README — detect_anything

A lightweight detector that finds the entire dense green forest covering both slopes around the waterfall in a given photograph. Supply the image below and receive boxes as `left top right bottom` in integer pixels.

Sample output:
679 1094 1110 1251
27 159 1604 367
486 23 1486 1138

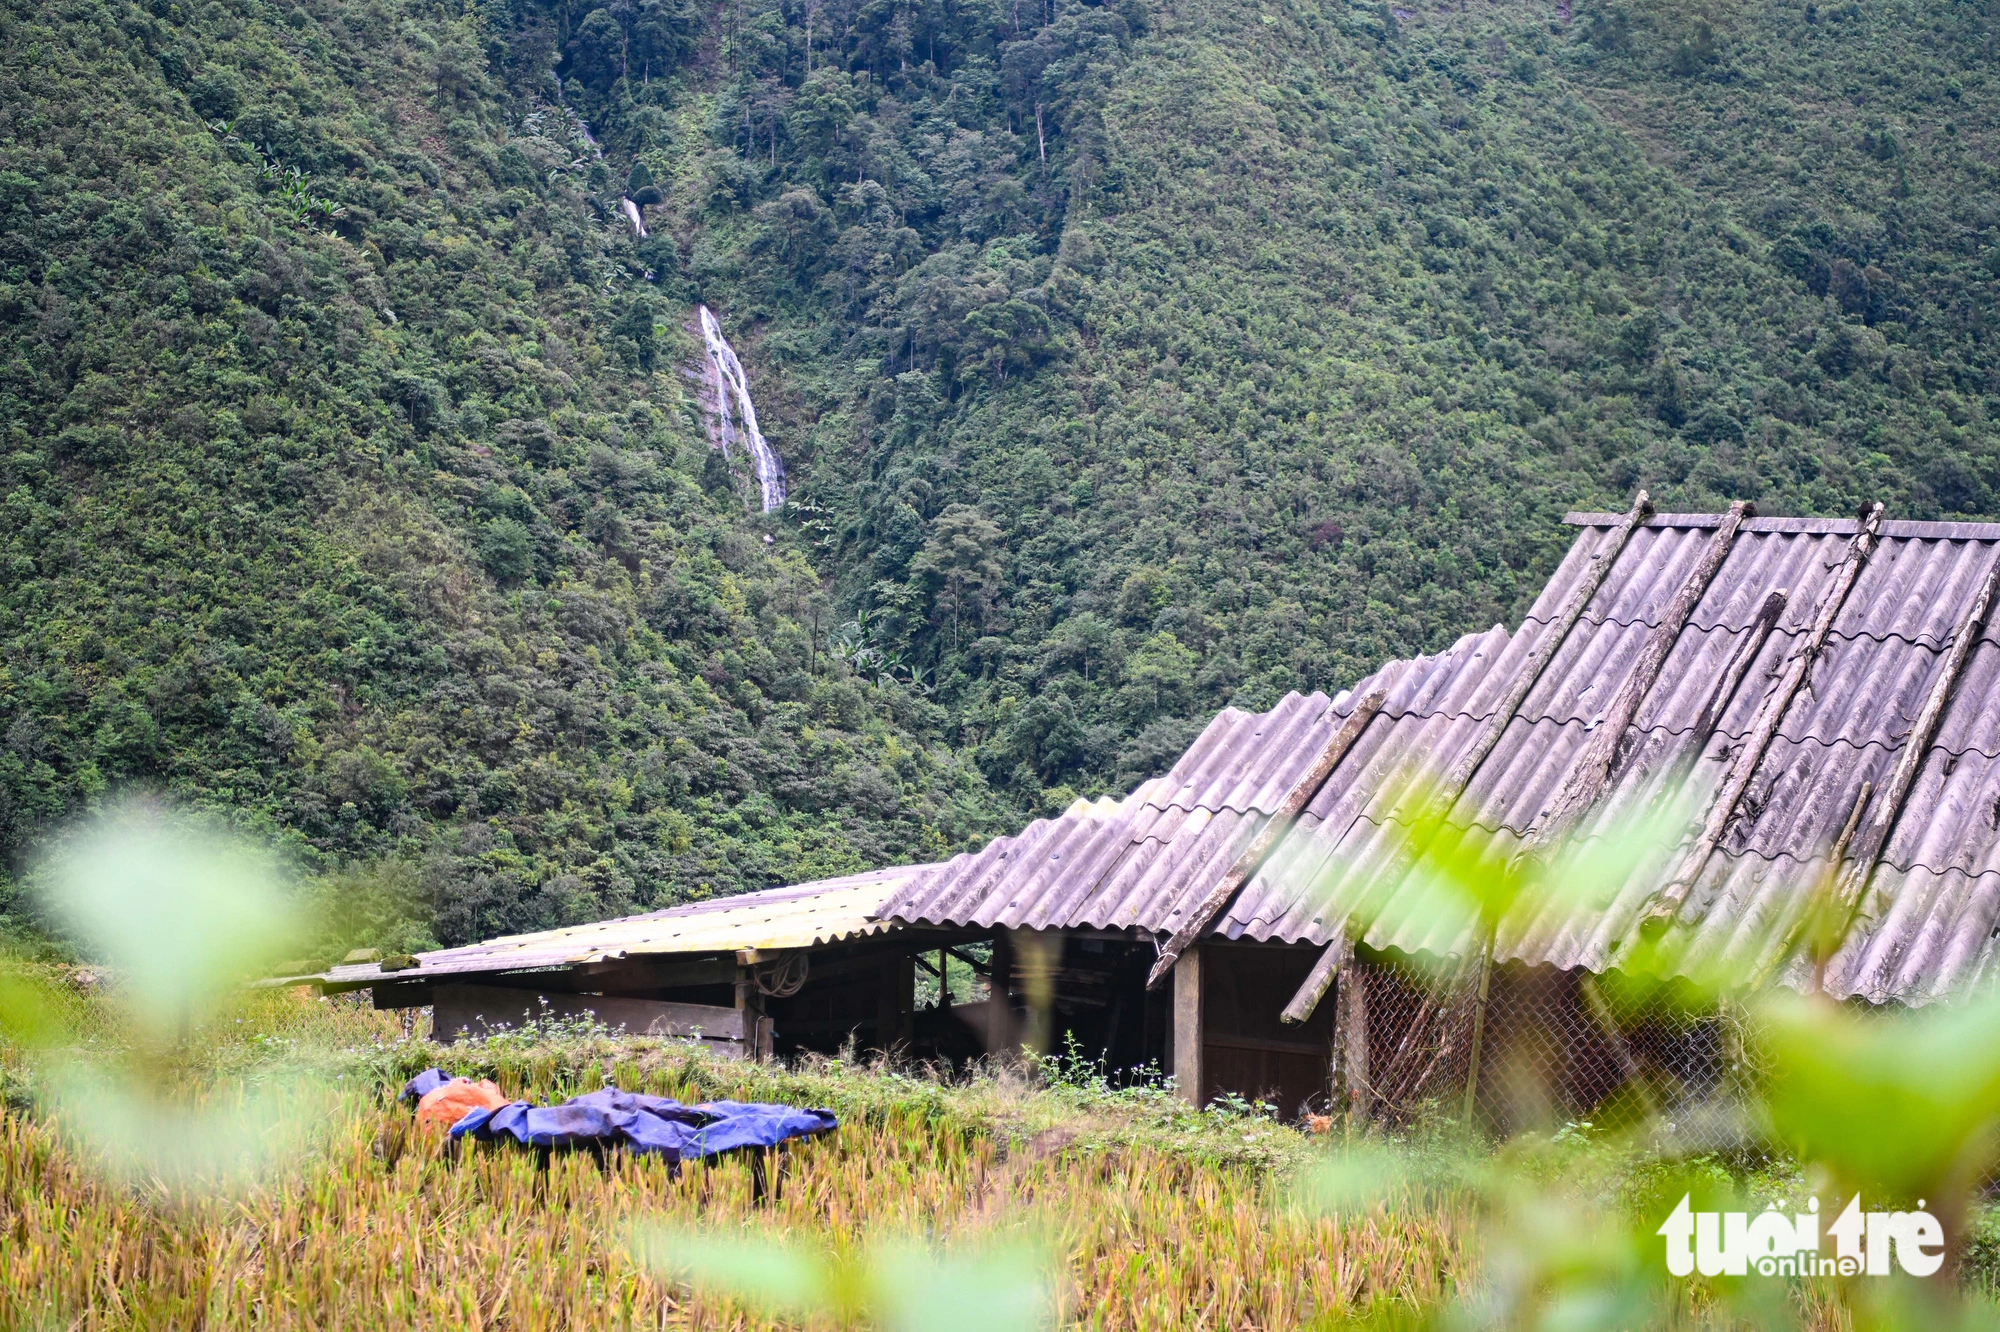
0 0 2000 948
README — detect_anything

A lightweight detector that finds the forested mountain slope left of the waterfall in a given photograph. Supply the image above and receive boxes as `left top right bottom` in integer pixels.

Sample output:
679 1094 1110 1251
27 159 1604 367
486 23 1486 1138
0 2 1002 940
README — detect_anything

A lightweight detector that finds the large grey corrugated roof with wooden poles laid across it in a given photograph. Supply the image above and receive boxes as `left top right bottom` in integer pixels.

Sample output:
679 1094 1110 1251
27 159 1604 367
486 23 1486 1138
882 514 2000 1002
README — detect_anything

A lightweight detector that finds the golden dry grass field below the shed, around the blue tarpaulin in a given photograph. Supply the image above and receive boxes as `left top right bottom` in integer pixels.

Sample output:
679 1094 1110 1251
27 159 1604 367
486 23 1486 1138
0 980 1466 1332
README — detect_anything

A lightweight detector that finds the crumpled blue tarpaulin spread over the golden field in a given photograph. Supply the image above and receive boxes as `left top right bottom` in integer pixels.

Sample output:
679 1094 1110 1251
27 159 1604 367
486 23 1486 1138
404 1068 840 1160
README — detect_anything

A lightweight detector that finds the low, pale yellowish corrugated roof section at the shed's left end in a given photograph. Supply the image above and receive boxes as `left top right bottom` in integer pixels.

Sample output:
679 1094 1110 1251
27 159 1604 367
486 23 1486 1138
318 866 932 988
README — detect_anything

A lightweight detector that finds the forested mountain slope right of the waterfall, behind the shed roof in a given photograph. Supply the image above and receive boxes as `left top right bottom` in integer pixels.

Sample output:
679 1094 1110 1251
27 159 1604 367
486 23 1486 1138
676 0 2000 790
